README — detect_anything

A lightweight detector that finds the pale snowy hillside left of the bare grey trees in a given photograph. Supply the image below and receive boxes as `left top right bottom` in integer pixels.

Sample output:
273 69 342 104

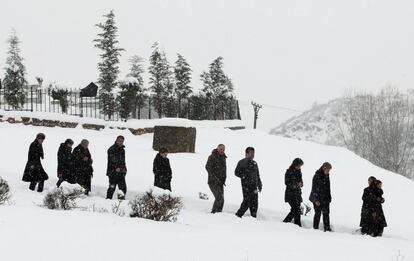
270 99 342 145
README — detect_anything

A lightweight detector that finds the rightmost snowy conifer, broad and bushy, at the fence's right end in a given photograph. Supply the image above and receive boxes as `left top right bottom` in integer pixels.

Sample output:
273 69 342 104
201 57 234 120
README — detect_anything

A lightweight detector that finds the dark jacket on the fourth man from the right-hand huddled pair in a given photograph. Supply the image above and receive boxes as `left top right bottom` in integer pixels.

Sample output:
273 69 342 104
234 158 262 191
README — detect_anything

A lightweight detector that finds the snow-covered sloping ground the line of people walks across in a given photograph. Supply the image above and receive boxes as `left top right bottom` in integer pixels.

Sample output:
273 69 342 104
0 123 414 261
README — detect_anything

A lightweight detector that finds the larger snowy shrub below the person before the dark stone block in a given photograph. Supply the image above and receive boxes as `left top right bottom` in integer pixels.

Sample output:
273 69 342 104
129 190 183 222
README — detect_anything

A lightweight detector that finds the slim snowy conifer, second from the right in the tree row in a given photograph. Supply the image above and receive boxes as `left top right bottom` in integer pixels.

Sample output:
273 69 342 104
174 54 193 118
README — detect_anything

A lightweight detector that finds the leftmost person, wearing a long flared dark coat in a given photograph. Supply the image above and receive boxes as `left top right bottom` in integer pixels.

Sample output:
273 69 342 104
22 133 49 192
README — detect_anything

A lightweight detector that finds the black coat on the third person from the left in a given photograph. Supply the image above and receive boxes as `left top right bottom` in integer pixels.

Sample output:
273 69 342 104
73 144 93 185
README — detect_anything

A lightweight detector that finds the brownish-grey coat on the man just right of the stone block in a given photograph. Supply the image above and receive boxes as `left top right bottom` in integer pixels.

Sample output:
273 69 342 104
206 149 227 185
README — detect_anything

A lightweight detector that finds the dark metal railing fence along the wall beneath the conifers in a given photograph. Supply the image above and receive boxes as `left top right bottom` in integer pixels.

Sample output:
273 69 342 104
0 87 240 121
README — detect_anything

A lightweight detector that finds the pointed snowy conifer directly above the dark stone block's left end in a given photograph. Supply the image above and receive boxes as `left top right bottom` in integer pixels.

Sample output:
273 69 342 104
149 42 173 118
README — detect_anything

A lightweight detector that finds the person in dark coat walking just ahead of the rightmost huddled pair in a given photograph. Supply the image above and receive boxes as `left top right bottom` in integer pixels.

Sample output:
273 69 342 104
309 162 332 232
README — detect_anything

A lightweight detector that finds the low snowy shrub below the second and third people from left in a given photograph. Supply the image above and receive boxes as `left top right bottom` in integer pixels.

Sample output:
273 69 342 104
43 187 84 210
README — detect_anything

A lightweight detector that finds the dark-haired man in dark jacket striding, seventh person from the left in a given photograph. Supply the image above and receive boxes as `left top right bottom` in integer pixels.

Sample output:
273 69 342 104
235 147 262 218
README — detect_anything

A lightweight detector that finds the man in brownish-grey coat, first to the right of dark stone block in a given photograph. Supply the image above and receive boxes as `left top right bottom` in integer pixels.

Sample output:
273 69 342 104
206 144 227 213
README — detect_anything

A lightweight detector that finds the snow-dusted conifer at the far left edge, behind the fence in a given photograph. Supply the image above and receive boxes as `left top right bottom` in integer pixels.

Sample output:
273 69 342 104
3 30 27 109
